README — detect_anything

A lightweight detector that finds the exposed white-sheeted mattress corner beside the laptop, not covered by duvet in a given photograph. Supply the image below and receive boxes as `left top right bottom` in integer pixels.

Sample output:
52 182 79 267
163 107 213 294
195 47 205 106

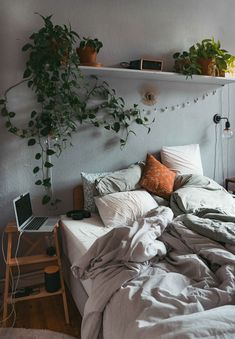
61 213 110 295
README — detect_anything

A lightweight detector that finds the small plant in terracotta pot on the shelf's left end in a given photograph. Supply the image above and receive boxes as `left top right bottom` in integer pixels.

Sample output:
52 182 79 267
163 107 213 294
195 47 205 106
77 37 103 67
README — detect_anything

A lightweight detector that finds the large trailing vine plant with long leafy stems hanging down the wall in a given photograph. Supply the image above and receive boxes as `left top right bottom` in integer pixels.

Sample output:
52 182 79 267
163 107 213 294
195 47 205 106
0 14 153 205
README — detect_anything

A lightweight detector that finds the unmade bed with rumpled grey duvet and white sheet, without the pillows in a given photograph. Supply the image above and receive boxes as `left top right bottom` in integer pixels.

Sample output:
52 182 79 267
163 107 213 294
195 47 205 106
62 169 235 339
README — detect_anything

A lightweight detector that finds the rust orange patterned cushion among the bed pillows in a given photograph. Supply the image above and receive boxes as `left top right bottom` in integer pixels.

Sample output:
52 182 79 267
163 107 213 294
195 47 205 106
139 154 176 199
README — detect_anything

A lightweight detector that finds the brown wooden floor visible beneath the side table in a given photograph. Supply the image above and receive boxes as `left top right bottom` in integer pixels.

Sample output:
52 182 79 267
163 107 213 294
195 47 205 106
1 292 81 339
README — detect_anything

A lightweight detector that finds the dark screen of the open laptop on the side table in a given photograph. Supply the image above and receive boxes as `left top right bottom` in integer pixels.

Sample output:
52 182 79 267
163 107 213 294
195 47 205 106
14 193 33 227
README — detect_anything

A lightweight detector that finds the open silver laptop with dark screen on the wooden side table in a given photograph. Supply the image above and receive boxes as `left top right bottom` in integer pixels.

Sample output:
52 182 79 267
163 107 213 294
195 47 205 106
13 192 58 232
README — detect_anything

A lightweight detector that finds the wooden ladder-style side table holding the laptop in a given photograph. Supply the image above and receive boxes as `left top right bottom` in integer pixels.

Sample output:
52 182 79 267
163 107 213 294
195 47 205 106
3 223 69 326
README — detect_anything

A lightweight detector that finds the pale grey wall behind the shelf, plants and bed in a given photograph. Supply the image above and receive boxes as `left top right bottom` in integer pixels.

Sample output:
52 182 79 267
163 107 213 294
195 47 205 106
0 0 235 278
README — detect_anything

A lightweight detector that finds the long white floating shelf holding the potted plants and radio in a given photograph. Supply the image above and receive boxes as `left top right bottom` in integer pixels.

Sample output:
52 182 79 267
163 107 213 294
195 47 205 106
79 66 235 86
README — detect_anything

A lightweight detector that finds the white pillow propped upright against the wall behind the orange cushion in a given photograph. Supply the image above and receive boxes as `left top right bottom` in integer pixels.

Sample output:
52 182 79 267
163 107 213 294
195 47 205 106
161 144 203 175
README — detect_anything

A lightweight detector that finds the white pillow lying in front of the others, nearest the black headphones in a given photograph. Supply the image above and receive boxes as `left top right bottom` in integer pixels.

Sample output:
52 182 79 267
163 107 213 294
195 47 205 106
94 190 158 227
